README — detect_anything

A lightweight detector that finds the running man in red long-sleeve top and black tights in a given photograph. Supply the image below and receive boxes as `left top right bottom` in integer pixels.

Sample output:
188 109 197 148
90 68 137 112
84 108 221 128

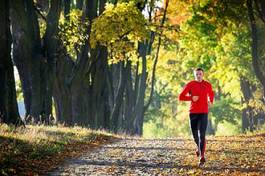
179 68 214 166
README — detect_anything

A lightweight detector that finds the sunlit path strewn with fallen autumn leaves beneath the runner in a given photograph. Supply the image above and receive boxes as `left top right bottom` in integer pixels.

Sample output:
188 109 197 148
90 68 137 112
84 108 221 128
50 134 265 176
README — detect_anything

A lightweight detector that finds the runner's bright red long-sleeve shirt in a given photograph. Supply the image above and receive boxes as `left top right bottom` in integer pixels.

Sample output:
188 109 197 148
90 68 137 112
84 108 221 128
179 80 214 113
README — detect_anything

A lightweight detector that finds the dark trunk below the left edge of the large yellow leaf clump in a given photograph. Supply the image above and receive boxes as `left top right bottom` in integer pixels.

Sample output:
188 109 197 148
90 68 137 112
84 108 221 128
86 0 110 128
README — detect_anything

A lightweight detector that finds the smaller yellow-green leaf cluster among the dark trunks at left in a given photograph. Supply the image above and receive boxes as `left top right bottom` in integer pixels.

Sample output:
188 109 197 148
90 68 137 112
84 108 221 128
58 9 89 59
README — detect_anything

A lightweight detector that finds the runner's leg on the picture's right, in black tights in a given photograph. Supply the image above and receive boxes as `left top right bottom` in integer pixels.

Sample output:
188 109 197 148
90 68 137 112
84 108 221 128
199 114 208 158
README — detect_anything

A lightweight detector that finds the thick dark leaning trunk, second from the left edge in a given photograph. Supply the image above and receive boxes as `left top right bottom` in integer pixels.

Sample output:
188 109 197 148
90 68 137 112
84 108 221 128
10 0 45 122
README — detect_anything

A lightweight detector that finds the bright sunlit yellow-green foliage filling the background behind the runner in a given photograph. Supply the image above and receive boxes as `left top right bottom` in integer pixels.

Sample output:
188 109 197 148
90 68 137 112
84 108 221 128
142 0 264 136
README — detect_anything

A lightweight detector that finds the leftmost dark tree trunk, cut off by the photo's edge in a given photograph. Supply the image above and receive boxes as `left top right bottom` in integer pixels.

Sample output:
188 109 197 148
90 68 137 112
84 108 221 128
0 0 22 125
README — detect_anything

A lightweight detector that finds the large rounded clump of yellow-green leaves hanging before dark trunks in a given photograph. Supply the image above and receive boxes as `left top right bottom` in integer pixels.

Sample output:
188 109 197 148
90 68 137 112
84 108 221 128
90 2 148 60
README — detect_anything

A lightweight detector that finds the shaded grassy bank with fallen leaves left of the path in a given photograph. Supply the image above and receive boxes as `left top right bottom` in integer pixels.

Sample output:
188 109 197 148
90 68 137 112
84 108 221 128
0 124 117 175
